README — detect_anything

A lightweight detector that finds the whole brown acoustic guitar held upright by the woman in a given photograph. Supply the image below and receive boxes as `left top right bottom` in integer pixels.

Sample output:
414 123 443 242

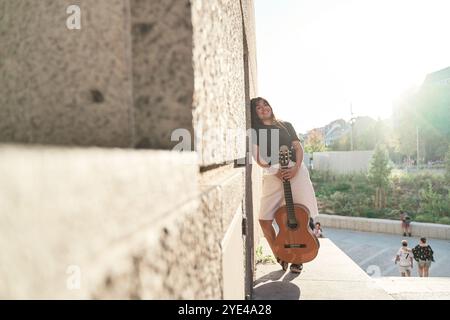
274 146 320 264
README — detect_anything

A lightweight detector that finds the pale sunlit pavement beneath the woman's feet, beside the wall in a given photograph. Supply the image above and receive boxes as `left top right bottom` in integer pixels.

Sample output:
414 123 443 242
253 238 393 300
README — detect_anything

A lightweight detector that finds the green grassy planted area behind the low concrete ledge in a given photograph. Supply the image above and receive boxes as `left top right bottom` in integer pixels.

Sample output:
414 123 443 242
311 171 450 224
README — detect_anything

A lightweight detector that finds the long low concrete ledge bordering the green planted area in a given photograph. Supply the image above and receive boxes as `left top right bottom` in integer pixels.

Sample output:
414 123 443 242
315 214 450 240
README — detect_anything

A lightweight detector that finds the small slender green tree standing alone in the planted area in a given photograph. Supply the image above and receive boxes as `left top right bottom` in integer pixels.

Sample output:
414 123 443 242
368 144 392 209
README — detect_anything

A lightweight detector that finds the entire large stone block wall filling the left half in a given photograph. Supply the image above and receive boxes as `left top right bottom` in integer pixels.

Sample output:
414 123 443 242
0 0 260 299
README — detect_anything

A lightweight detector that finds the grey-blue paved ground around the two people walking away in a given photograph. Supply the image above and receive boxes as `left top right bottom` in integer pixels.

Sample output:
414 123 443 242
323 228 450 277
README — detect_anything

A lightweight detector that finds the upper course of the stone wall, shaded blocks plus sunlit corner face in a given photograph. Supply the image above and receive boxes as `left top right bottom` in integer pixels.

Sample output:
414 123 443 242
0 0 256 156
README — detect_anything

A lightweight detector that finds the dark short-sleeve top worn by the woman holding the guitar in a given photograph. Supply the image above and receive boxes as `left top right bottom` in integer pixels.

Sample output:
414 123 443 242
253 121 300 165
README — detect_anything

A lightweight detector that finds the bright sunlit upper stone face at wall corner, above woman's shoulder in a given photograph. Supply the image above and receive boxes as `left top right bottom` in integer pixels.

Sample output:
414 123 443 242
192 0 245 166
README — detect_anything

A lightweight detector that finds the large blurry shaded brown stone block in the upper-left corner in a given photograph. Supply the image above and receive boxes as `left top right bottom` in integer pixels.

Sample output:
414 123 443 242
0 0 134 147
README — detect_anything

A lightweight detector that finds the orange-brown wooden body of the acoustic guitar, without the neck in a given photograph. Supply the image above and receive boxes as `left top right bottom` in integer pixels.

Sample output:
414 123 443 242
275 204 320 264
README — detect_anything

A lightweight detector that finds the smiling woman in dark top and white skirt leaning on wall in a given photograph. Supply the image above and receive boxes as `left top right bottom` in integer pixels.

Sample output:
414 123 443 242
251 97 318 273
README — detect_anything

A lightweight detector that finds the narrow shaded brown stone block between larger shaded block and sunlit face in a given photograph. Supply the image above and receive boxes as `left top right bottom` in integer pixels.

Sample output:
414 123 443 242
131 0 194 149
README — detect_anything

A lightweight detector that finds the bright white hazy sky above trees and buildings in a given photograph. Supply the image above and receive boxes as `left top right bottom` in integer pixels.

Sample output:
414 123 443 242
254 0 450 133
